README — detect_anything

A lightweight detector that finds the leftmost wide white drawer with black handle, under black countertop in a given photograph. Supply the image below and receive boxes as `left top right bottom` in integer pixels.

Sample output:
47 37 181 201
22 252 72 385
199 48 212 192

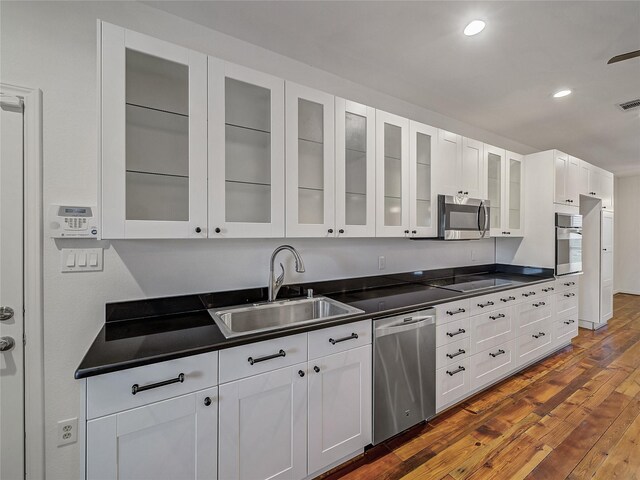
87 352 218 420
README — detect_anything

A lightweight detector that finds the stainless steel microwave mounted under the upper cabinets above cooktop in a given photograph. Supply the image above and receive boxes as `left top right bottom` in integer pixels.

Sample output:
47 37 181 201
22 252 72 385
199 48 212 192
438 195 490 240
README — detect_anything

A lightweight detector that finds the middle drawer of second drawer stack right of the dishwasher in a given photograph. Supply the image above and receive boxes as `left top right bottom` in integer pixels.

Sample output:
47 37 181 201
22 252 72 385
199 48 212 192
469 307 517 353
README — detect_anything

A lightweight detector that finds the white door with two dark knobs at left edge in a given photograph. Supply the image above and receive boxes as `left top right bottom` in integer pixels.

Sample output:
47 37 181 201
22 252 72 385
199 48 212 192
0 93 24 479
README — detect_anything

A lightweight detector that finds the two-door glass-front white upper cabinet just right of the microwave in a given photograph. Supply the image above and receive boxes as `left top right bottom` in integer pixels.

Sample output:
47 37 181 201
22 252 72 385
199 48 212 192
484 145 524 237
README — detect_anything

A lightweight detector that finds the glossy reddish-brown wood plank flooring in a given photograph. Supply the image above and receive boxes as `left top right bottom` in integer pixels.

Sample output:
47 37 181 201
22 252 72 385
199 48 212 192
323 294 640 480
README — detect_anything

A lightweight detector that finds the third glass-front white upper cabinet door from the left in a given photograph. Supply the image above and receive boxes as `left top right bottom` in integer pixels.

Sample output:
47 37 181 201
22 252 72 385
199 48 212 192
285 82 335 237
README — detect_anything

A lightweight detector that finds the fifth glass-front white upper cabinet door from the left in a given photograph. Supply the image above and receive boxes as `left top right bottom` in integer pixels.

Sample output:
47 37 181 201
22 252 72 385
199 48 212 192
376 110 409 237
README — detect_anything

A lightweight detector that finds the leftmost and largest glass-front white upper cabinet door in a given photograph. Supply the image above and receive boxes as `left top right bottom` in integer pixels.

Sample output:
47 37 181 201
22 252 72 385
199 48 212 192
100 22 207 238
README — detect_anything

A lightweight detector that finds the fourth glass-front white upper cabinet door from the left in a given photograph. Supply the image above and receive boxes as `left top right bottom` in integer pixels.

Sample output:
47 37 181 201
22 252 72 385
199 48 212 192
334 97 376 237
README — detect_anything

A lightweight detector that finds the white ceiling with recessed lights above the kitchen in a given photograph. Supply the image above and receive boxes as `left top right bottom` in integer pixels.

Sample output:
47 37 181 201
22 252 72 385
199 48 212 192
145 1 640 175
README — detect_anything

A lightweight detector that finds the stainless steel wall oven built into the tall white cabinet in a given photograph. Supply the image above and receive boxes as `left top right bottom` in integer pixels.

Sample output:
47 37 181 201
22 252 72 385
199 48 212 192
556 213 582 275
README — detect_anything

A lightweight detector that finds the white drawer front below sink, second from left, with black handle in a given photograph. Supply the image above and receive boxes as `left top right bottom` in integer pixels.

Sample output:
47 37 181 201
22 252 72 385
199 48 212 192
220 333 307 384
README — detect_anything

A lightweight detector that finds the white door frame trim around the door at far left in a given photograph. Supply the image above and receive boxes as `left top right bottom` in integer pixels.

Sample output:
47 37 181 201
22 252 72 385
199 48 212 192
0 83 45 479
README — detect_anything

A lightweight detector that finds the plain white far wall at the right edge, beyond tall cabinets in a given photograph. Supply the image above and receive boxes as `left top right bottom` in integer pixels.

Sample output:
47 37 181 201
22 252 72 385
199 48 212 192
613 176 640 295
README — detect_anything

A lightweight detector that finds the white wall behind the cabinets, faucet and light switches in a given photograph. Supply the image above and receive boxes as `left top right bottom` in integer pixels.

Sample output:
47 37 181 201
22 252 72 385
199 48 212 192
0 1 532 480
